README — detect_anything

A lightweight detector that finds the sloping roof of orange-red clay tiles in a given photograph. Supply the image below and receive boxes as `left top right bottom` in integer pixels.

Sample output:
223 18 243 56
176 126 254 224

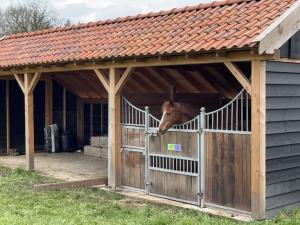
0 0 297 68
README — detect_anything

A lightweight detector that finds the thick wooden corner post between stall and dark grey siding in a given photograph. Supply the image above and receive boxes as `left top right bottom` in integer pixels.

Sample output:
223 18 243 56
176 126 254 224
251 61 266 219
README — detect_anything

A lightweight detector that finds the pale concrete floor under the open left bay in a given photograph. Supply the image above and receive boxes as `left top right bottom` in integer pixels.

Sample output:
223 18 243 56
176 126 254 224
0 152 107 181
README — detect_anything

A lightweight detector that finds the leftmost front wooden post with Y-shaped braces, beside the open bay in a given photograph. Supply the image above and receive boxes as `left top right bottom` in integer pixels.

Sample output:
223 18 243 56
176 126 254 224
14 73 41 170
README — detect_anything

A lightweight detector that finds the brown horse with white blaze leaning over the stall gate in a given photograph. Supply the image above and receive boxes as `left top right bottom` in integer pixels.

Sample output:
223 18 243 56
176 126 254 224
158 101 198 134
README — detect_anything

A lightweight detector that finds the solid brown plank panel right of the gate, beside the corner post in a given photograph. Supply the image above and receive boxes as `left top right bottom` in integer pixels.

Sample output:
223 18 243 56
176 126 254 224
205 132 251 212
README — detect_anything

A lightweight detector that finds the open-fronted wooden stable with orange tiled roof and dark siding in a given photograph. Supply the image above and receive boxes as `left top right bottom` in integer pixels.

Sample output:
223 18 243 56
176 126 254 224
0 0 300 219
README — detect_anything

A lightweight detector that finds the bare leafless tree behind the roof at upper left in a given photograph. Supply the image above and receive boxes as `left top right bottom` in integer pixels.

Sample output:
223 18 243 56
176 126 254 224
0 0 67 35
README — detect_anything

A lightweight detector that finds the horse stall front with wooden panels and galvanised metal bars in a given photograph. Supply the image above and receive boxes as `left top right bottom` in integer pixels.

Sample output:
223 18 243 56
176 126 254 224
121 64 251 214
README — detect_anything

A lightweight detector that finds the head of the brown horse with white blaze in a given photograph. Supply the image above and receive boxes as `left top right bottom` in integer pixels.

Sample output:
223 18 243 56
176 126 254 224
158 101 181 134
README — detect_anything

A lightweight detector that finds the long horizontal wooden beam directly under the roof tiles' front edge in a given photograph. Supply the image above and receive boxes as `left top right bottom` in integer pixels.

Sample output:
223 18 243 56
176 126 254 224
0 50 277 76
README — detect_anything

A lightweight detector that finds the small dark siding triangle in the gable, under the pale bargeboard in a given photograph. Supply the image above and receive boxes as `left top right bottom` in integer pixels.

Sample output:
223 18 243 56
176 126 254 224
280 31 300 59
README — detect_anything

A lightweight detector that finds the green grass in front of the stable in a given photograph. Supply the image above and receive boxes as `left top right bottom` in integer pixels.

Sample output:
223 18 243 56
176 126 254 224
0 166 300 225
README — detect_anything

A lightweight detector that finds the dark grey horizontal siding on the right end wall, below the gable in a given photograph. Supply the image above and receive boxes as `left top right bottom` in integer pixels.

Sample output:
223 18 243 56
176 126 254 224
266 62 300 217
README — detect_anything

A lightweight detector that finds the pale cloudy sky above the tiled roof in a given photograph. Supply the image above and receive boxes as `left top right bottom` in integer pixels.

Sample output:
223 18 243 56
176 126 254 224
1 0 211 23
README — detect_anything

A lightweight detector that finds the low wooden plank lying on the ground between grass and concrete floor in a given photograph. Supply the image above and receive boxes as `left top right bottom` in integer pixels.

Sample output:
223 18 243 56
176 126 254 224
33 177 108 192
